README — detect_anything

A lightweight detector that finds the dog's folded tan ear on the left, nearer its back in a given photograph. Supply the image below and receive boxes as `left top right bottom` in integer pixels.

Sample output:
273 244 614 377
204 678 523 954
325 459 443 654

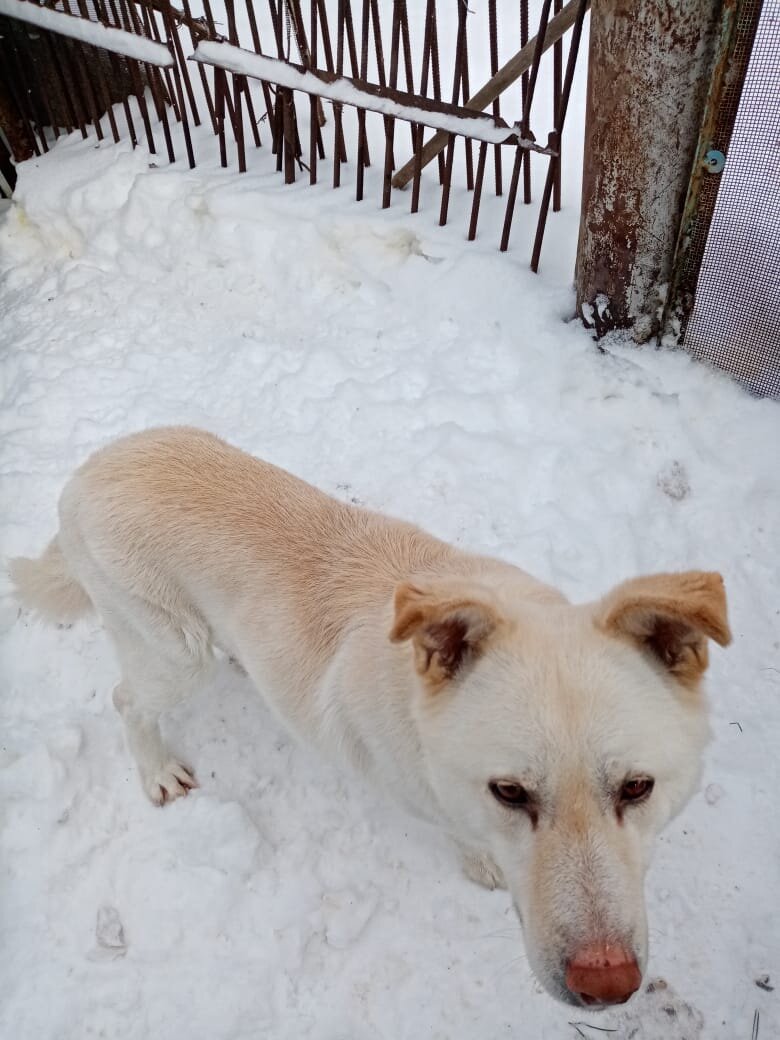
390 579 501 690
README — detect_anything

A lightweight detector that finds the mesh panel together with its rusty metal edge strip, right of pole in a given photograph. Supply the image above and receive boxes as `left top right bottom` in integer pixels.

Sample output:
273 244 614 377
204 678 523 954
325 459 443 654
667 0 780 396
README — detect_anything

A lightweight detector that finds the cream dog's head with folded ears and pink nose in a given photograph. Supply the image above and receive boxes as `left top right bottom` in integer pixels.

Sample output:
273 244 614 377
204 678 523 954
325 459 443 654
391 572 731 1005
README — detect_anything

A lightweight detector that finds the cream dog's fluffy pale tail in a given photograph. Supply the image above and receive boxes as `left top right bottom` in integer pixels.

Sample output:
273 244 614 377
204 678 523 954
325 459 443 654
8 538 93 623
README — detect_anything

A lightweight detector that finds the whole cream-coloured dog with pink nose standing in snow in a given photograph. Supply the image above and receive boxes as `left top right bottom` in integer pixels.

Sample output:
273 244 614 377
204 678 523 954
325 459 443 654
11 427 730 1005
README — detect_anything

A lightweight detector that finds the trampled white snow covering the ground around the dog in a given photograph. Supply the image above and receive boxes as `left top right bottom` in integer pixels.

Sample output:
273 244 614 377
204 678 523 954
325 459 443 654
0 24 780 1040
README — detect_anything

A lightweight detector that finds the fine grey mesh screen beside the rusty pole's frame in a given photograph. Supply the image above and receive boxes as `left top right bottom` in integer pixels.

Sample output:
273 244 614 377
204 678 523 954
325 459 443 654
684 0 780 396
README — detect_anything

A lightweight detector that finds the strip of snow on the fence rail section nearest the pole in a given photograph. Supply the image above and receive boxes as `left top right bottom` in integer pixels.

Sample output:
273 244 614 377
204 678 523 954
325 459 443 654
192 40 550 154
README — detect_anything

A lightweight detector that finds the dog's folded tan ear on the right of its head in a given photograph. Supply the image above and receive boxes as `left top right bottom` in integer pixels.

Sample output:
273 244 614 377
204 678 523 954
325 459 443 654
596 571 731 685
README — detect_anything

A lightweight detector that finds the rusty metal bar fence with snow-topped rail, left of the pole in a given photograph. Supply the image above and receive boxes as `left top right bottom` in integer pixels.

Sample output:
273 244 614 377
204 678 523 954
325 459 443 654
0 0 590 269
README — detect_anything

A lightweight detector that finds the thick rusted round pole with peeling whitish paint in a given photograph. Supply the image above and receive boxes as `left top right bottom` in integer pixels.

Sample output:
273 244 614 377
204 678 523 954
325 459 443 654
576 0 737 342
